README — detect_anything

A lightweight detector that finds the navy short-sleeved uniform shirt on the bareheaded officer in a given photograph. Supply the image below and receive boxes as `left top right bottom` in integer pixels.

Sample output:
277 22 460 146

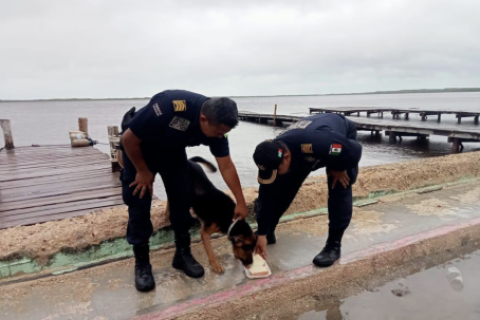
129 90 229 157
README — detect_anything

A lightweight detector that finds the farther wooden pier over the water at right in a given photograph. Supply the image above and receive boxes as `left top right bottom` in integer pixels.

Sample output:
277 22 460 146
310 107 480 125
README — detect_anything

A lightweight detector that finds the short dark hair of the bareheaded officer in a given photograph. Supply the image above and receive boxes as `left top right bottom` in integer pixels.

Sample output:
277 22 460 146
202 98 238 128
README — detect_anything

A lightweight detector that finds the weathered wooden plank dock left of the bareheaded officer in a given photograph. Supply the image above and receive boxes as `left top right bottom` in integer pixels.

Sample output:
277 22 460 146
0 145 123 229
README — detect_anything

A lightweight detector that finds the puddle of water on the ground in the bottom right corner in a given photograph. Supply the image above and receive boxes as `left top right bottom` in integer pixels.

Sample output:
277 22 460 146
247 246 480 320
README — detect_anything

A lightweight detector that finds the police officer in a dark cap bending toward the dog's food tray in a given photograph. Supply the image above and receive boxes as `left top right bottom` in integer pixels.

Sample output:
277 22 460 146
253 113 362 267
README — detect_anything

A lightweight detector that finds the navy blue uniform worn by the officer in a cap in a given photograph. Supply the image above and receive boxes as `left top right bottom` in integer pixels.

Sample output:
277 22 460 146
257 113 362 235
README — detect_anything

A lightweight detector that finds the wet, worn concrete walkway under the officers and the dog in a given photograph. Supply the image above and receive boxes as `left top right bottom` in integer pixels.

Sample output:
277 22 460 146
0 182 480 320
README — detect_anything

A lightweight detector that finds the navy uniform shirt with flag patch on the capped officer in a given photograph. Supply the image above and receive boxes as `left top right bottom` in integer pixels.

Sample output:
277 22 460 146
257 113 362 235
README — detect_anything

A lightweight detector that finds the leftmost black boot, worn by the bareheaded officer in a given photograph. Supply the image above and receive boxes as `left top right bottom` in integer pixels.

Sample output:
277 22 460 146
133 244 155 292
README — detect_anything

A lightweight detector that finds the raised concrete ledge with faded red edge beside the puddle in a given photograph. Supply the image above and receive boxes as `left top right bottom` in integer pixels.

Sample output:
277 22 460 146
135 218 480 320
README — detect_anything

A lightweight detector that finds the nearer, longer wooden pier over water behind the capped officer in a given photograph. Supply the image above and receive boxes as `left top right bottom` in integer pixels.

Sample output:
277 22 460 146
239 109 480 153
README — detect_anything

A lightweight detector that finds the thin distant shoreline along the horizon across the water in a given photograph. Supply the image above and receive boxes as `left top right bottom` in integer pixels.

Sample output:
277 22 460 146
0 88 480 103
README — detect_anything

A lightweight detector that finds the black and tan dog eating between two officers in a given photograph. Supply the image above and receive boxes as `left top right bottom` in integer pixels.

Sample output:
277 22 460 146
188 157 257 273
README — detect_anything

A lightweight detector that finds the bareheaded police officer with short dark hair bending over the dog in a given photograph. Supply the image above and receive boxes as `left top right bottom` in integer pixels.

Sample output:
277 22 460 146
121 90 247 291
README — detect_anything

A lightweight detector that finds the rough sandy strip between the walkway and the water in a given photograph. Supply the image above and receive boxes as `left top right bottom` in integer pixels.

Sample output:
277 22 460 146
0 152 480 263
